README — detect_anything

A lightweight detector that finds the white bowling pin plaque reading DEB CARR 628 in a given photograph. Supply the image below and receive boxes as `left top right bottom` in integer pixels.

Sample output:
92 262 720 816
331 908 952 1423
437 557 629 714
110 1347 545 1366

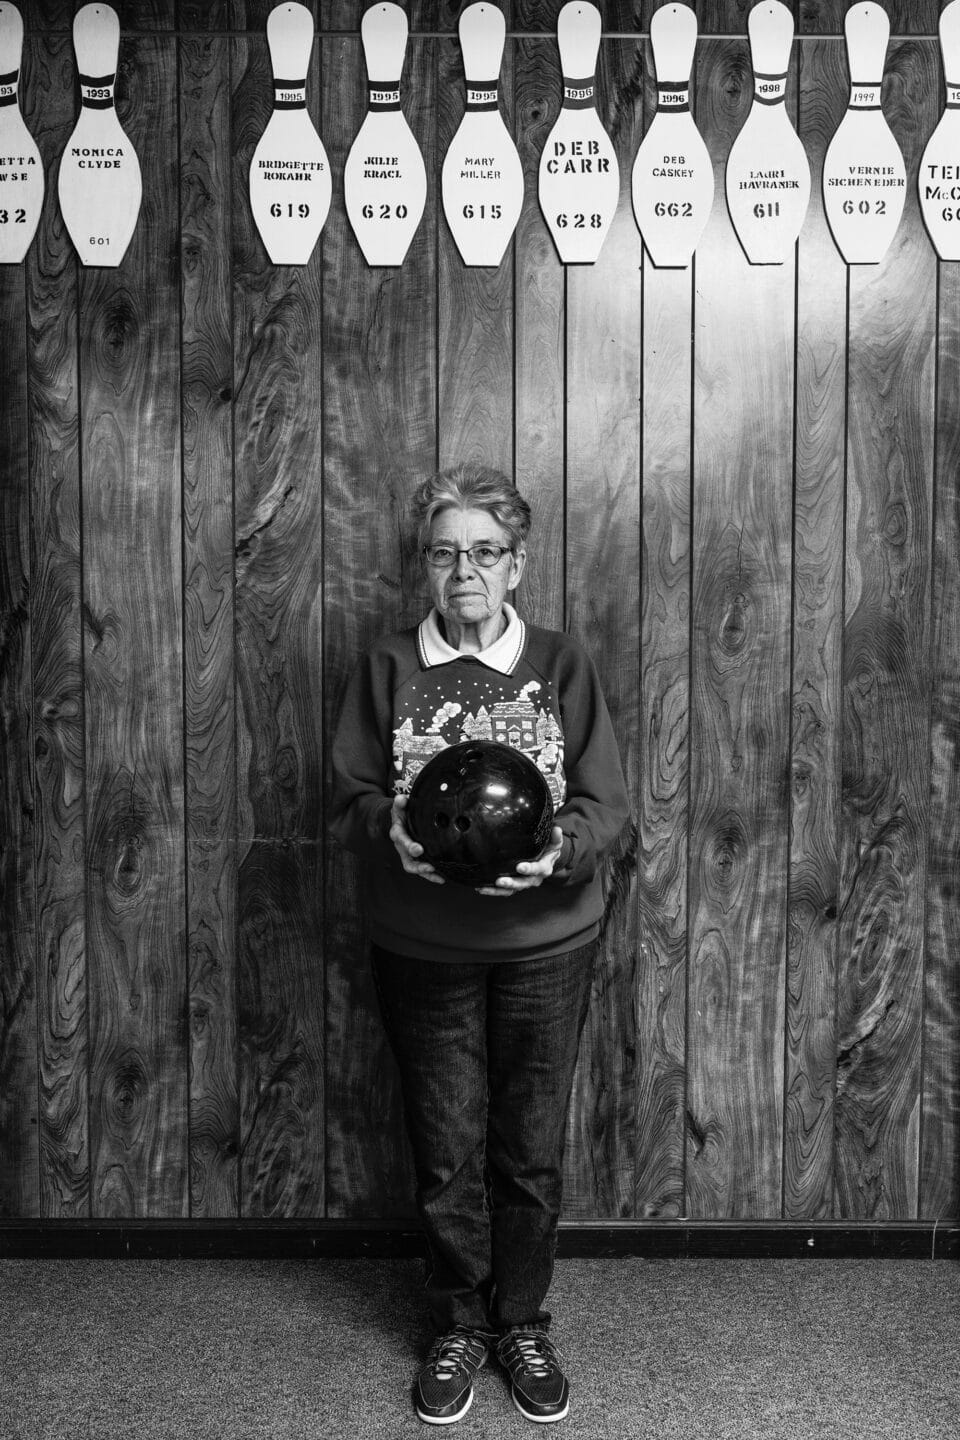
538 0 620 265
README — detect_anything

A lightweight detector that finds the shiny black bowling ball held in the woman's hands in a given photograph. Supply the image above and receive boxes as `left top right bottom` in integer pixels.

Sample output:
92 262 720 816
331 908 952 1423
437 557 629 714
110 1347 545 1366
406 740 553 886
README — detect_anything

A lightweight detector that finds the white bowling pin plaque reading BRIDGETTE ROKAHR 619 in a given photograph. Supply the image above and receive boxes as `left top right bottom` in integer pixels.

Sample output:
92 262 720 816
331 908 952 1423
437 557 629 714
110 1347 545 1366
250 4 331 265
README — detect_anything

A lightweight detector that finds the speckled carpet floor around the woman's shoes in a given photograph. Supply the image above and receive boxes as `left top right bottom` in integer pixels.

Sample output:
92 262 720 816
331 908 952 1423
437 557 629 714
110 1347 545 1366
0 1259 960 1440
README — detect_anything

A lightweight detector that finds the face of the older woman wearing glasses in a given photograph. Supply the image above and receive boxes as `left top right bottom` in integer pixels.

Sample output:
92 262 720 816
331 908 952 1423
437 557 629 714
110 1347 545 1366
426 507 527 625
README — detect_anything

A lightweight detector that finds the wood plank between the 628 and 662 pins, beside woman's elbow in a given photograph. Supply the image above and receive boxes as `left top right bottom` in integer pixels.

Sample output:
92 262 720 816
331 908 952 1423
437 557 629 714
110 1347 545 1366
564 40 643 1217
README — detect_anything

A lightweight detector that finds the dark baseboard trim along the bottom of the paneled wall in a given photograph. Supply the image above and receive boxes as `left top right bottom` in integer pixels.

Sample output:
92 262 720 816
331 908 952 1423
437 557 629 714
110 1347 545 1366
0 1220 960 1260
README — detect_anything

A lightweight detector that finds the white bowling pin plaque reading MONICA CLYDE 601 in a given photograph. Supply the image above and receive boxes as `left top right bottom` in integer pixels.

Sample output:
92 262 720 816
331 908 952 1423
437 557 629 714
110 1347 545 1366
58 4 142 268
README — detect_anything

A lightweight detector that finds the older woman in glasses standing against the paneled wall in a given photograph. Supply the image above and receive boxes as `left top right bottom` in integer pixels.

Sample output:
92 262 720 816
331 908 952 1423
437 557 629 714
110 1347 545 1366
332 465 628 1424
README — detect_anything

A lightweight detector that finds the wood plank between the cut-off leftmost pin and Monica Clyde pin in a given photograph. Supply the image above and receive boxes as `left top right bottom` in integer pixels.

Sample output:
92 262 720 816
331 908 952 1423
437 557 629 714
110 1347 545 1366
23 35 89 1220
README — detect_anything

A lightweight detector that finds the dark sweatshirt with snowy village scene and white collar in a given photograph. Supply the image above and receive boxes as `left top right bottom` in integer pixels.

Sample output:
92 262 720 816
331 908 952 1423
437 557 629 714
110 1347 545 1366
331 606 629 962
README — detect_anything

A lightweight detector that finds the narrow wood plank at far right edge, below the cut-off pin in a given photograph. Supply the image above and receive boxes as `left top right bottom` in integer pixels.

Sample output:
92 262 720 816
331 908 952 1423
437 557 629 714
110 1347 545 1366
920 256 960 1220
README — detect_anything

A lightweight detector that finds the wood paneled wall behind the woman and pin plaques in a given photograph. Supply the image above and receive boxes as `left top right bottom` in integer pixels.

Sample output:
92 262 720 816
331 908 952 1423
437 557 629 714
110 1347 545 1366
0 0 960 1223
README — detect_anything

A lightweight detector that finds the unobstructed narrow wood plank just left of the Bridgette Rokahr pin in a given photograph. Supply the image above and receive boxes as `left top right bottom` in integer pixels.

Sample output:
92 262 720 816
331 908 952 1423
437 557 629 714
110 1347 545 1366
178 36 239 1217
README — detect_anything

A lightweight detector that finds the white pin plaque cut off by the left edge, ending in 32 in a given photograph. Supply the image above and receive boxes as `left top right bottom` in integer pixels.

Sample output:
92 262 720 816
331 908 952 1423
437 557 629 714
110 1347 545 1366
0 0 43 265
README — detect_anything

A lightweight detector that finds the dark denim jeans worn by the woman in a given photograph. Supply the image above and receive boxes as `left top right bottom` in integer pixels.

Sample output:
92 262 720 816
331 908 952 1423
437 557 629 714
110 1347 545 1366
373 938 597 1333
